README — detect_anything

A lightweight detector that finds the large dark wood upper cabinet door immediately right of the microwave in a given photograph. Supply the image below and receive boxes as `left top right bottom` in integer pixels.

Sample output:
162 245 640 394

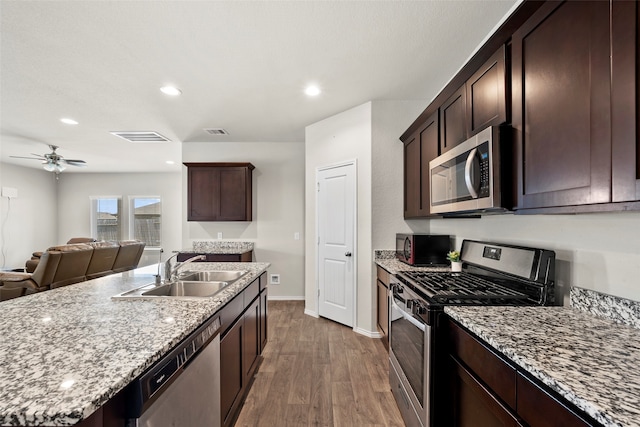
512 1 611 209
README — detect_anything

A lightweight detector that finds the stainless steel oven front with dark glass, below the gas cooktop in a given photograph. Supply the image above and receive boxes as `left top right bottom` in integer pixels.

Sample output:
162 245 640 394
389 283 431 426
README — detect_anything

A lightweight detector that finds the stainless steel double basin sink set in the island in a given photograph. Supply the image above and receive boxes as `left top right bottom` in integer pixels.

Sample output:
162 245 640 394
112 270 247 299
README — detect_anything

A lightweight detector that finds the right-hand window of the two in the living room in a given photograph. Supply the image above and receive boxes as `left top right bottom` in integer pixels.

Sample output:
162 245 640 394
129 196 162 247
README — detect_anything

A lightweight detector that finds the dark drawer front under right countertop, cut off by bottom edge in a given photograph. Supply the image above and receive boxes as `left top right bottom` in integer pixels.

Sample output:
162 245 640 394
517 373 592 427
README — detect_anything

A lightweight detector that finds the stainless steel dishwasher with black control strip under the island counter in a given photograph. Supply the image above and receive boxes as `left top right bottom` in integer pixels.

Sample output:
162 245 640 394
126 317 220 427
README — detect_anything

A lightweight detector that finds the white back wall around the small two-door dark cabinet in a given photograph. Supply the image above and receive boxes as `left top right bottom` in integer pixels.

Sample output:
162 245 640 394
182 142 305 299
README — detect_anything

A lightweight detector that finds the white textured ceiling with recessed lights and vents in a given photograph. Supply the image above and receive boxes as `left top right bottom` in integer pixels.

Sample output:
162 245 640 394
0 0 516 173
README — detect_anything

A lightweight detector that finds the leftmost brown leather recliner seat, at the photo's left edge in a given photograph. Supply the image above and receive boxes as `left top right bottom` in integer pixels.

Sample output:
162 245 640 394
0 252 60 301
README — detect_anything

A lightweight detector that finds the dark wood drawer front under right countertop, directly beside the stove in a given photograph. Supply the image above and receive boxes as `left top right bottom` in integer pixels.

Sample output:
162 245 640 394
449 322 516 410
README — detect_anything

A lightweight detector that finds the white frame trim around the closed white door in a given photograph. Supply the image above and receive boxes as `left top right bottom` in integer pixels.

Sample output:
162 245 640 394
315 159 359 331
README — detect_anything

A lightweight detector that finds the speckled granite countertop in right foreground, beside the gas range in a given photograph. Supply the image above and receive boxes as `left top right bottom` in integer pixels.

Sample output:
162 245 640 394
445 306 640 426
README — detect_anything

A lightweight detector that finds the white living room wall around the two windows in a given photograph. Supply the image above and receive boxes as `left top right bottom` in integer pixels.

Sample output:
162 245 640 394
56 172 182 266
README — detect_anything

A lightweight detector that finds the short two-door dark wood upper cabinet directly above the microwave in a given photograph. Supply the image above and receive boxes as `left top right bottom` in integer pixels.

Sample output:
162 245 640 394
440 46 507 154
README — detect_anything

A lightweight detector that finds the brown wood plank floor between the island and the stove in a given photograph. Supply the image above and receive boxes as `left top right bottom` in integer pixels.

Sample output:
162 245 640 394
236 301 404 426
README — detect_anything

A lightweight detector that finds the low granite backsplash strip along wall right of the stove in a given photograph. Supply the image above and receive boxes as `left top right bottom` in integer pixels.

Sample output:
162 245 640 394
569 287 640 328
